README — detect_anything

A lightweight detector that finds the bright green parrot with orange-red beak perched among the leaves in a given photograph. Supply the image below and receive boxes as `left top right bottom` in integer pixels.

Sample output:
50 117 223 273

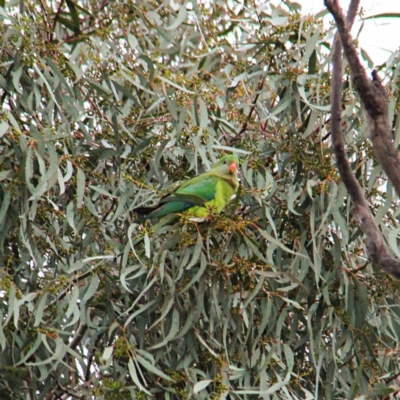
133 155 239 219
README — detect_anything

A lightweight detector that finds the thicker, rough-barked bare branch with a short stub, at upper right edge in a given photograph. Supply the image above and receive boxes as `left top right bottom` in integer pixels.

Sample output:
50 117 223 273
325 0 400 197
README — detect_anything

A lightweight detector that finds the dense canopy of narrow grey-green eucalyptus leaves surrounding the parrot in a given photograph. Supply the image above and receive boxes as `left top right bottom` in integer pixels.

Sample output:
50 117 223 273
0 0 400 400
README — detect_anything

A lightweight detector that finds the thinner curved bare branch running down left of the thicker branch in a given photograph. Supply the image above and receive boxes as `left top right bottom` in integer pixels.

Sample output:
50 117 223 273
325 0 400 278
